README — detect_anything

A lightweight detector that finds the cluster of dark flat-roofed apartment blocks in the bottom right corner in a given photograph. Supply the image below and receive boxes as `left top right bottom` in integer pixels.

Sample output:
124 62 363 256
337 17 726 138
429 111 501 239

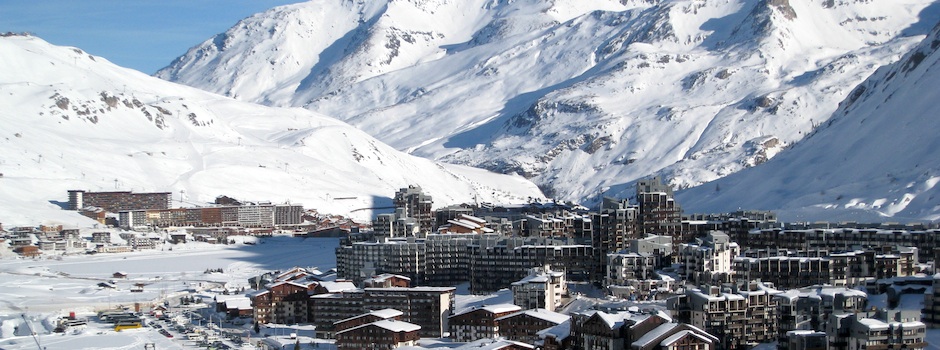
668 282 928 350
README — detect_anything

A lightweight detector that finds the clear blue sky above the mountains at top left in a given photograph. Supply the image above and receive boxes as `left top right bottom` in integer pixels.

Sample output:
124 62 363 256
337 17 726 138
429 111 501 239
0 0 302 74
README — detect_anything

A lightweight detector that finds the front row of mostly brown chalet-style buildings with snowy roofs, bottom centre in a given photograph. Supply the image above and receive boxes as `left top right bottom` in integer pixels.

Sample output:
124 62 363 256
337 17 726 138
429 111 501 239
242 267 718 349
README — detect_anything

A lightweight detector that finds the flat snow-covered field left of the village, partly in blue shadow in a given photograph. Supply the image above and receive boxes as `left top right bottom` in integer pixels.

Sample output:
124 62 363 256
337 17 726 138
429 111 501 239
0 237 339 350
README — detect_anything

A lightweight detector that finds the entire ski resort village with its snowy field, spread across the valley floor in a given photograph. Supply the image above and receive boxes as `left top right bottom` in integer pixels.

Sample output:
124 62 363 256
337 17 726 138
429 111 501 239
0 177 940 349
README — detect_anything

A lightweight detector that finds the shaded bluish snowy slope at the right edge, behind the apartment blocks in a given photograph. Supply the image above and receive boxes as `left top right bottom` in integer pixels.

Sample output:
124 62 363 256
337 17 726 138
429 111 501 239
679 20 940 221
